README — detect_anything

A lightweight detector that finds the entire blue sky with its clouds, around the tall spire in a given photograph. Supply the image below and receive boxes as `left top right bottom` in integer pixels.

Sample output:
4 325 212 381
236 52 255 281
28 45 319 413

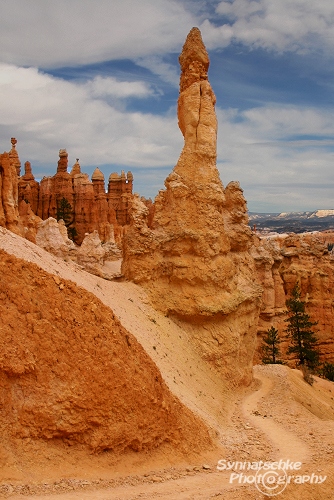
0 0 334 212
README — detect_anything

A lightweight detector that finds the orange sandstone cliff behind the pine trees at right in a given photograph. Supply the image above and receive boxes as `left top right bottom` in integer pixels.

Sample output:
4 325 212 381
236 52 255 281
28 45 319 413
252 233 334 365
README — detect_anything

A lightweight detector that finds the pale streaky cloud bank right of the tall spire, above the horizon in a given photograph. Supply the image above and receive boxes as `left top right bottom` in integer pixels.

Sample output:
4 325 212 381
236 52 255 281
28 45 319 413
218 106 334 212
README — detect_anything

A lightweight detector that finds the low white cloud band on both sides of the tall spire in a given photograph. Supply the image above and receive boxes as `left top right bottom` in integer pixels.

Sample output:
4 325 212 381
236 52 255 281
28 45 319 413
0 60 334 211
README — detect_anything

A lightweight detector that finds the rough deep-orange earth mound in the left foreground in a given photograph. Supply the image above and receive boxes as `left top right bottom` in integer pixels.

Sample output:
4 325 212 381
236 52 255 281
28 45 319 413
0 251 210 453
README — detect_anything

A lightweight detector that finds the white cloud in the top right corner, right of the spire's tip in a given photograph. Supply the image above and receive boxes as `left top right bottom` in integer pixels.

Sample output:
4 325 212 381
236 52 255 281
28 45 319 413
203 0 334 53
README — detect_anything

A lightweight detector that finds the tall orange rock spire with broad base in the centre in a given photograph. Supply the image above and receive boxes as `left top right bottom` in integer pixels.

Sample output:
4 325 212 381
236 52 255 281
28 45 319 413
122 28 262 383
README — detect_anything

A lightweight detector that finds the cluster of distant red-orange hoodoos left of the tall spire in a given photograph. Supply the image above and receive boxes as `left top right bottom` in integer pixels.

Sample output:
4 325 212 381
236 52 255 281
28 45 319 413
12 148 133 244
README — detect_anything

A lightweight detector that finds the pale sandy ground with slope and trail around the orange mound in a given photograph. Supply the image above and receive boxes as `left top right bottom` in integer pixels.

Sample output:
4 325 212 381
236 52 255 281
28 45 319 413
0 228 334 500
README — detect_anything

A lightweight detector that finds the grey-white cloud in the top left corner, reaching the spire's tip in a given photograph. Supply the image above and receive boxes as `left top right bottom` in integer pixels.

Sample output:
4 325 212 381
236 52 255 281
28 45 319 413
0 0 195 68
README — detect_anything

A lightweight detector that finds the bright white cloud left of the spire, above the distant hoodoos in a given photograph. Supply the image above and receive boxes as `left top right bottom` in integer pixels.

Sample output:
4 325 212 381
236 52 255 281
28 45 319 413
0 64 182 169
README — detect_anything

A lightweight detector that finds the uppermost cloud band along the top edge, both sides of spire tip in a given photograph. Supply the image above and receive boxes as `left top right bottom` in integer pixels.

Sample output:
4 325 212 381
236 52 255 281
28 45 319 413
0 0 334 68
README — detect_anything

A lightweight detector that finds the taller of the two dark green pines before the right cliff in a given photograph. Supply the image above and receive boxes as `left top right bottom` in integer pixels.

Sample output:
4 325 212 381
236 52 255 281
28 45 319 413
285 284 319 368
